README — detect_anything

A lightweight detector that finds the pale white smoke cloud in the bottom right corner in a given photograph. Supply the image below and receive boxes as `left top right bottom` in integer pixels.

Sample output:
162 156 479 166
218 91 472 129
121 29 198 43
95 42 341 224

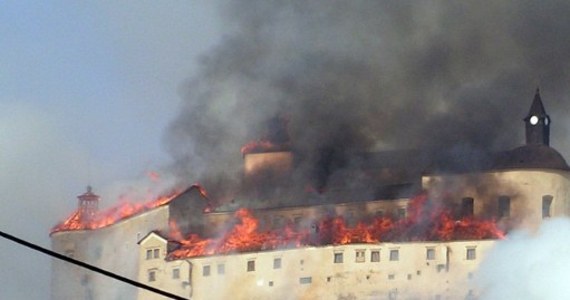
476 219 570 300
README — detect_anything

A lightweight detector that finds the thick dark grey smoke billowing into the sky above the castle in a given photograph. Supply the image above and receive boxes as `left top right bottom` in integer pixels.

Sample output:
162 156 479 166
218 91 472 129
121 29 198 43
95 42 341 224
166 0 570 195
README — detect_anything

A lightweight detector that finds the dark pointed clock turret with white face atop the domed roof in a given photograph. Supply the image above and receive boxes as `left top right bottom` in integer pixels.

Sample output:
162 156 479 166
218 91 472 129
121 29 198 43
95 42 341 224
524 88 550 146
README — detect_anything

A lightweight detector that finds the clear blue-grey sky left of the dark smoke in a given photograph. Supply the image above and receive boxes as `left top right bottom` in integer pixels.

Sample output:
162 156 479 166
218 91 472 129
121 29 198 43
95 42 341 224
0 1 220 299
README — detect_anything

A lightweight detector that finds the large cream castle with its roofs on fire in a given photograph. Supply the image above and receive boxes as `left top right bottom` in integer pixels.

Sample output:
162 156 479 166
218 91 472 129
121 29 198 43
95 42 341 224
51 90 570 299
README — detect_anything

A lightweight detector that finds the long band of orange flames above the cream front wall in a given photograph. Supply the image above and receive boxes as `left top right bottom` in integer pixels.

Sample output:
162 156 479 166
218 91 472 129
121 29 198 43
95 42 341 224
168 194 504 259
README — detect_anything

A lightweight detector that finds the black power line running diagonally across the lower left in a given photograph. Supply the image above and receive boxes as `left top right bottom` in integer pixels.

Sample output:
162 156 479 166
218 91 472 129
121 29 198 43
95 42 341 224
0 231 188 300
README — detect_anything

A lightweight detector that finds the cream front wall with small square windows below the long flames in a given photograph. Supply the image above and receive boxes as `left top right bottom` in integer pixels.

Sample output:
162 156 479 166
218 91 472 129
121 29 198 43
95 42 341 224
138 235 495 300
